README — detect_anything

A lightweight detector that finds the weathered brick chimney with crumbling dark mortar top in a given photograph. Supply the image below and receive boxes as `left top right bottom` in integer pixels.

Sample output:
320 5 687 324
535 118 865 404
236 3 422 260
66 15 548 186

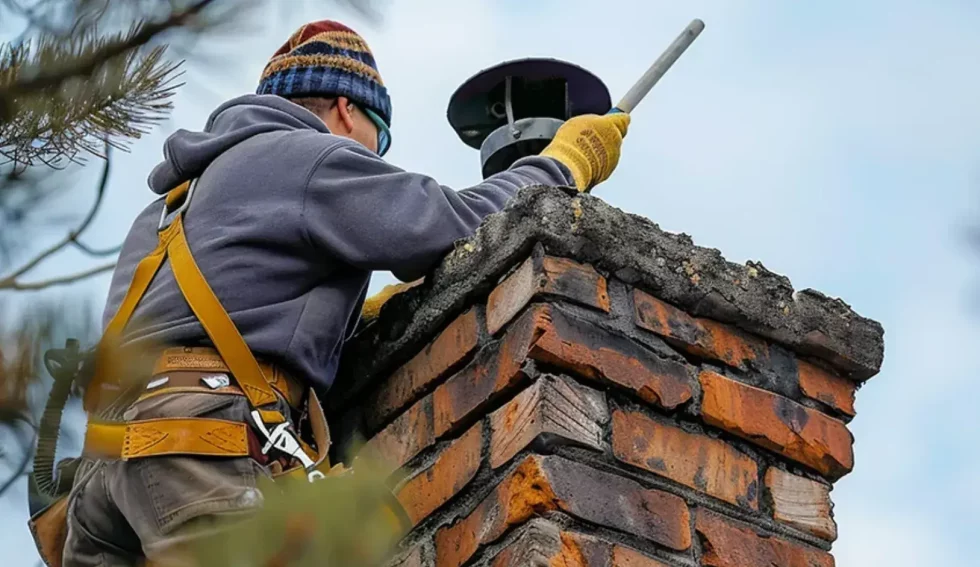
329 188 883 567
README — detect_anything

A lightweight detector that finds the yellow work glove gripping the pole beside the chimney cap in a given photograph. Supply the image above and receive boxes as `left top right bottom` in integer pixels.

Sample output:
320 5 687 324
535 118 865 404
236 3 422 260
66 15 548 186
541 113 630 191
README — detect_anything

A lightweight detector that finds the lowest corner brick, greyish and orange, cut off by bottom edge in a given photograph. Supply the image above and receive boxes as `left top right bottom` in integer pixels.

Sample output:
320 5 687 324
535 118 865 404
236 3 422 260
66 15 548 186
490 519 666 567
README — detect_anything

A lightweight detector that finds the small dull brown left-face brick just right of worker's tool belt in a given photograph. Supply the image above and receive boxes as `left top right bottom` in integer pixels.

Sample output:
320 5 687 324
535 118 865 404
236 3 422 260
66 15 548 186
364 397 436 480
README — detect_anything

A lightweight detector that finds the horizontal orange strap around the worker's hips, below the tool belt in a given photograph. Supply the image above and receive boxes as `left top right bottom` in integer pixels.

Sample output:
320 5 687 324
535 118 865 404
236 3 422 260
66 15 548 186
82 418 249 461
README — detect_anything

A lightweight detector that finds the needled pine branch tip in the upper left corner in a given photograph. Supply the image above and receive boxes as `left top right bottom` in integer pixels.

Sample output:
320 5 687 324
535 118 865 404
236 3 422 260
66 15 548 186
0 32 180 169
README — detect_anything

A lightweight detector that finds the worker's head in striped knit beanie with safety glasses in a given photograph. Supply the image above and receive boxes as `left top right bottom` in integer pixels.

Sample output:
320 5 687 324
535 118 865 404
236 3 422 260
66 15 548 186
256 20 391 155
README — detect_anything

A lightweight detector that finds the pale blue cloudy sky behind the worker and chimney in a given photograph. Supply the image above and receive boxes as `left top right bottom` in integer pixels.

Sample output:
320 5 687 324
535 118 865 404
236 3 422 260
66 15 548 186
0 0 980 567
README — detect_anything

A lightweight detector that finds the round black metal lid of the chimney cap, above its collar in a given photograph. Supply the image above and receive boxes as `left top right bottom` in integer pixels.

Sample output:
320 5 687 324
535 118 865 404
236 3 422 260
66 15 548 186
447 58 612 149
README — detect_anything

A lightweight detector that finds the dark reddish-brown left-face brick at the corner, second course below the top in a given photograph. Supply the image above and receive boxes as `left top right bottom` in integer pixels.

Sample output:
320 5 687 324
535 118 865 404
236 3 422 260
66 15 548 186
432 306 550 437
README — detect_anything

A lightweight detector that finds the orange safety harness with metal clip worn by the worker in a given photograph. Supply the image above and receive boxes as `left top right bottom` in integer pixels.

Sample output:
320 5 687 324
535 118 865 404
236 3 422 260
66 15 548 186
29 180 411 566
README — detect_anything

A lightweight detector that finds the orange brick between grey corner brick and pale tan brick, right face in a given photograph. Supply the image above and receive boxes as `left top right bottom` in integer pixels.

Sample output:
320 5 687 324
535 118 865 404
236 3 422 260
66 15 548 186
612 410 759 510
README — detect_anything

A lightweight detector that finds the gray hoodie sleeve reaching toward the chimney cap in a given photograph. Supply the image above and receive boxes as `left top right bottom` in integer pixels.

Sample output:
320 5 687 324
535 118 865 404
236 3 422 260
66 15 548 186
303 141 574 282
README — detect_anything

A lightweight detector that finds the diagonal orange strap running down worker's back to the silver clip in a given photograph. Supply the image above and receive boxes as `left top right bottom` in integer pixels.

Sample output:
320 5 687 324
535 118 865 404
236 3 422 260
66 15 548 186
167 215 286 423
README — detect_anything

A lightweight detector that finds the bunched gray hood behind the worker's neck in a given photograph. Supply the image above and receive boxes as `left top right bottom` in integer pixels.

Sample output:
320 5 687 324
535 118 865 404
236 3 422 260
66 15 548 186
148 94 330 195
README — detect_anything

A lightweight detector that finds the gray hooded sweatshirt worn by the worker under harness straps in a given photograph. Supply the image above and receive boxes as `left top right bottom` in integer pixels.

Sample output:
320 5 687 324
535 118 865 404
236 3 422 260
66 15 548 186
103 95 574 395
